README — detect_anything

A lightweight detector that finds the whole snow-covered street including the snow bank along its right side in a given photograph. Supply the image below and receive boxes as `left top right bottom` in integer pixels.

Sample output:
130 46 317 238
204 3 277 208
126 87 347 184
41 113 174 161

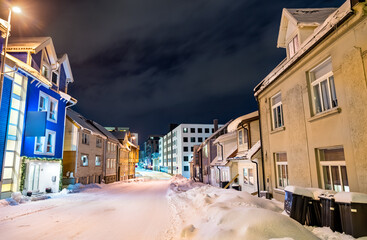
0 170 360 240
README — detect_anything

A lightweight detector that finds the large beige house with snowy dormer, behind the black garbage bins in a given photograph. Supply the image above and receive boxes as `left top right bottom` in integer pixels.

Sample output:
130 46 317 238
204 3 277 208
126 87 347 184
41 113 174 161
255 1 367 200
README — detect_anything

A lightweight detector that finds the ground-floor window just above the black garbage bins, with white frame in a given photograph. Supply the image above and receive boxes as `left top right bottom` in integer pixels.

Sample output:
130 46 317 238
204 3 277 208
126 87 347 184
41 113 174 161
318 147 349 192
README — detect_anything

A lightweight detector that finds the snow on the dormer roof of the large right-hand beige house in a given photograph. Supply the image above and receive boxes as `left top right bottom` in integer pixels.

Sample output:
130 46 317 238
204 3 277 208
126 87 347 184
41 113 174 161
285 8 337 24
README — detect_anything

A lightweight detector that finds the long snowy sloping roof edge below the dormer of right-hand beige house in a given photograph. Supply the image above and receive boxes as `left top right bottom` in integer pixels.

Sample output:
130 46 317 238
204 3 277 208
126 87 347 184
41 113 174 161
254 1 353 97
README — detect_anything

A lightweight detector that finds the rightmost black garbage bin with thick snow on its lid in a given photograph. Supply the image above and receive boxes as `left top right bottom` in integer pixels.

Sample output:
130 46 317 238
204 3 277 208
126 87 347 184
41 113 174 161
335 192 367 238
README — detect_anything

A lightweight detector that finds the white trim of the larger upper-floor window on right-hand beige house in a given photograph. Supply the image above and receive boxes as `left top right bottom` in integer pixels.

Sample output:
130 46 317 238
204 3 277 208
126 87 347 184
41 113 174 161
308 57 338 115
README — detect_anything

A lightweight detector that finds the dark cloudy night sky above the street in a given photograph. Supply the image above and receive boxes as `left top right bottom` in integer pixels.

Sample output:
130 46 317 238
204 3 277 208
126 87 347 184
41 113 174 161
0 0 344 143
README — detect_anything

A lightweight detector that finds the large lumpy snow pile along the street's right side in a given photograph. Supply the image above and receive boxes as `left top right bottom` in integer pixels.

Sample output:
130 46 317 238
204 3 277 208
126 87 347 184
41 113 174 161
167 182 318 240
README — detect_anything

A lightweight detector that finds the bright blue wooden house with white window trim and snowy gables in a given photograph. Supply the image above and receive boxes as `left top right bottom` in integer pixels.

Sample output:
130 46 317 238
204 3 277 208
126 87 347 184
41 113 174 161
0 34 76 198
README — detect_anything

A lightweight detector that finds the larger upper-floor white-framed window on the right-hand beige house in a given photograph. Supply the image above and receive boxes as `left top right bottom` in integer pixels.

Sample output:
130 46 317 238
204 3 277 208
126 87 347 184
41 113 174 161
310 58 338 114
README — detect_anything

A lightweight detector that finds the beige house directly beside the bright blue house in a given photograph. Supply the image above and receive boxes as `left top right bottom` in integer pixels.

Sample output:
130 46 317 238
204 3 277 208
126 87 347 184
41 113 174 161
63 109 106 184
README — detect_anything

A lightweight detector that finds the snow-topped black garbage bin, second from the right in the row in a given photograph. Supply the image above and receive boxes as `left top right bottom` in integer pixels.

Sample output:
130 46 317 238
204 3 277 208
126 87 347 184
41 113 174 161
319 194 343 232
